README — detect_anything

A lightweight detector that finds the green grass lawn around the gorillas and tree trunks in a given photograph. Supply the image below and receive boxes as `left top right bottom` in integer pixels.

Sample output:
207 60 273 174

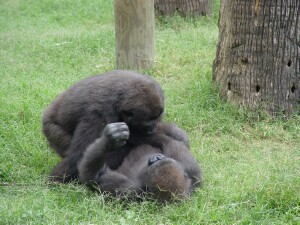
0 0 300 224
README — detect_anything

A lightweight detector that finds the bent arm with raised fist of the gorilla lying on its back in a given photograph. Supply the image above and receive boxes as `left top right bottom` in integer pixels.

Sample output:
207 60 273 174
78 123 139 195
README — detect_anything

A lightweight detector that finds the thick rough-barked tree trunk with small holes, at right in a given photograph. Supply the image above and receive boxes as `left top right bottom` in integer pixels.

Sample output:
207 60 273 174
213 0 300 115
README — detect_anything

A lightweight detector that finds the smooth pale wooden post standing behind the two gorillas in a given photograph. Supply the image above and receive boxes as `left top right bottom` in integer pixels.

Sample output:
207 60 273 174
115 0 155 69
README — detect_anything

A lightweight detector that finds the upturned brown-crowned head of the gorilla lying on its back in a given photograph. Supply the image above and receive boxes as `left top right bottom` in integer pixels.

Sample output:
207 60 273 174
146 154 191 202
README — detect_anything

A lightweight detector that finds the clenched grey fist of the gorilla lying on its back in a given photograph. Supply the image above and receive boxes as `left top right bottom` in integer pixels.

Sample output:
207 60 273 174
102 122 129 150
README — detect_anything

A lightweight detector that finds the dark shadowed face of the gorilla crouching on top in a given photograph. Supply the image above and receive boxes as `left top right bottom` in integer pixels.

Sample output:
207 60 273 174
121 108 163 135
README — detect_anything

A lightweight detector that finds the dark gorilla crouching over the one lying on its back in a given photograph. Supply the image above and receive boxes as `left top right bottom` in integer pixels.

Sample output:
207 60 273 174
42 71 188 182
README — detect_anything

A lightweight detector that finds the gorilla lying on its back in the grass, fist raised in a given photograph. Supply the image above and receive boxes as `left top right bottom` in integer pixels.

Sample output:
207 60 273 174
79 123 201 202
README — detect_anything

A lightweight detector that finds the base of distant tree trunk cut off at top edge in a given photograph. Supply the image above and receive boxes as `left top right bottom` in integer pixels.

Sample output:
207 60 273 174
154 0 213 16
